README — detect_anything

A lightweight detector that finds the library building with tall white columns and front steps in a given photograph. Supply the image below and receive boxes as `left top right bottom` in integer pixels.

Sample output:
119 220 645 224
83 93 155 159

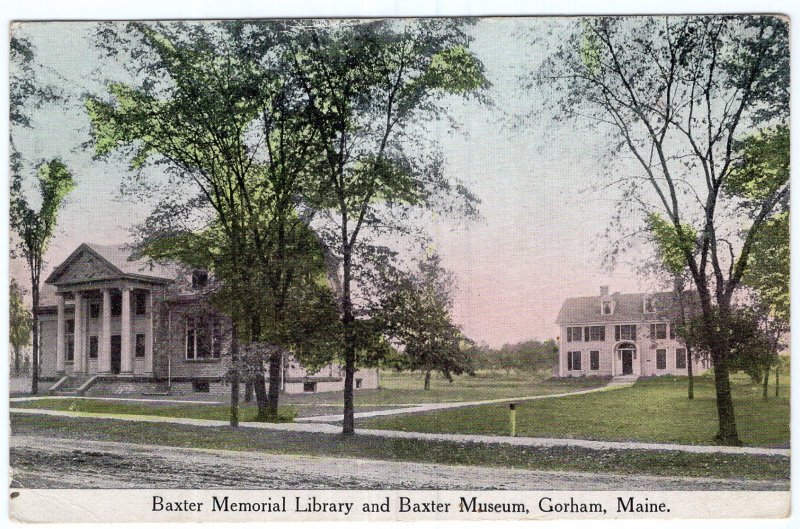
34 243 378 395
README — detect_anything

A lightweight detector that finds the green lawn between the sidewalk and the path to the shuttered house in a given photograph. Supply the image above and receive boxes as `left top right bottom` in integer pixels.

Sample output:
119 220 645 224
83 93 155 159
359 375 790 447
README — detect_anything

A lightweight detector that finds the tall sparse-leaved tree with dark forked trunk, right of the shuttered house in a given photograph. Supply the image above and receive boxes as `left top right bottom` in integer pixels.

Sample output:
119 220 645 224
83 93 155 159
536 16 789 445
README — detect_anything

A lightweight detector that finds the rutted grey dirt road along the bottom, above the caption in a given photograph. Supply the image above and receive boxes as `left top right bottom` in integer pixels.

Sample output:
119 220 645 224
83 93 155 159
11 435 789 490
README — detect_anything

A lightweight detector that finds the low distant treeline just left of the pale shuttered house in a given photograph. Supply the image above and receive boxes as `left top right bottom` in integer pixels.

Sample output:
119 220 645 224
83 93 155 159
473 340 558 371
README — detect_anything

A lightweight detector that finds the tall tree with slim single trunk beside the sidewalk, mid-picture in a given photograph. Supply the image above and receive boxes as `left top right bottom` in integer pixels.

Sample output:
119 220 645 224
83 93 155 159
286 19 488 434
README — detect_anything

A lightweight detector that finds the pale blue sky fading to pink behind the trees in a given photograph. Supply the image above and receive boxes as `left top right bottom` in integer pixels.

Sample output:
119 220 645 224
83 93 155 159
10 18 653 347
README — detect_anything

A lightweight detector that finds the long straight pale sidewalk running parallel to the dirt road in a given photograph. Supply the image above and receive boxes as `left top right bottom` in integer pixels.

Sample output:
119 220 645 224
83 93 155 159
10 408 790 457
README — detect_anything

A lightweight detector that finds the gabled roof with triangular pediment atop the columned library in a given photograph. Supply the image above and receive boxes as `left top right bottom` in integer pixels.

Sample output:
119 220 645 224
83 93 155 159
45 243 176 285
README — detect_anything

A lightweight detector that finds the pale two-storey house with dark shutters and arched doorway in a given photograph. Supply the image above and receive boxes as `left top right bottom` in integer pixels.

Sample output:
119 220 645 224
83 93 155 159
556 286 708 378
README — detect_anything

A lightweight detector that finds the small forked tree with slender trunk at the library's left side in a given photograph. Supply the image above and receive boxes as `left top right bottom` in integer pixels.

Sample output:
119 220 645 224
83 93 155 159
9 159 75 395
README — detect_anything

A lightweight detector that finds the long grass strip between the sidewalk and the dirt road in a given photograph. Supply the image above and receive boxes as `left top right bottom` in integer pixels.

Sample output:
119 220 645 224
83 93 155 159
11 415 789 480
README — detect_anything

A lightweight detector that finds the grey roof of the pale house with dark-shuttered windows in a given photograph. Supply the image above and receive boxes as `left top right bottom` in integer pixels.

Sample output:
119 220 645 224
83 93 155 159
556 292 677 325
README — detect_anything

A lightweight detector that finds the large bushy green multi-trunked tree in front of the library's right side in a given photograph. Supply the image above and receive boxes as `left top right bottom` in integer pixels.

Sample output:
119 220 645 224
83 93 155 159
87 21 336 419
